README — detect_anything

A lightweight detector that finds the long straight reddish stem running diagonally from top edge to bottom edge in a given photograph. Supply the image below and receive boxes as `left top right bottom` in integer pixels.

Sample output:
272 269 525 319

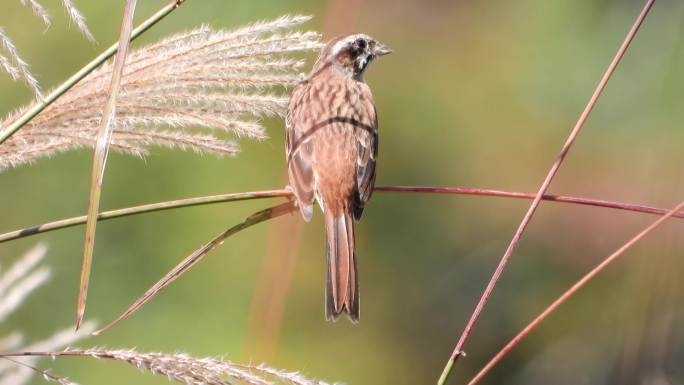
437 0 655 385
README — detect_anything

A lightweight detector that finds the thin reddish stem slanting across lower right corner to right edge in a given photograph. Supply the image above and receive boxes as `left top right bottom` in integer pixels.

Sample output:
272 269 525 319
468 202 684 385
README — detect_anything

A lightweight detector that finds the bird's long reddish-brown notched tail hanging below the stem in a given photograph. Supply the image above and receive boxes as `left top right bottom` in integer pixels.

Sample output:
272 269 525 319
325 210 359 322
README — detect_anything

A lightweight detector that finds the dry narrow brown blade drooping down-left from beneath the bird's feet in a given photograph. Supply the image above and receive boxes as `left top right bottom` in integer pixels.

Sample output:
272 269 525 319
93 201 296 335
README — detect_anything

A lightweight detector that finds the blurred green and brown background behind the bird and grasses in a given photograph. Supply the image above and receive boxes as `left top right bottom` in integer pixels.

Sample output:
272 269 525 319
0 0 684 385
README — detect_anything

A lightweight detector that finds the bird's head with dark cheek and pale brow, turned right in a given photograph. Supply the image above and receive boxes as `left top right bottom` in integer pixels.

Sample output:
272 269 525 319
314 34 392 79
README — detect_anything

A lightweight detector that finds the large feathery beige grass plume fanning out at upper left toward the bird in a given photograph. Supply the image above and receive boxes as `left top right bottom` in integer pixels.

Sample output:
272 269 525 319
0 16 321 171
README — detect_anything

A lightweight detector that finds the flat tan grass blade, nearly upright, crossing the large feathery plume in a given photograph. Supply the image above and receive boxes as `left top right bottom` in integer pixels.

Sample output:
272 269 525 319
76 0 138 330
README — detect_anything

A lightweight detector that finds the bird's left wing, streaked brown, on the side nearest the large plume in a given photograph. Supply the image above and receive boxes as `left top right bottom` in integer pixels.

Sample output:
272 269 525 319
285 83 315 221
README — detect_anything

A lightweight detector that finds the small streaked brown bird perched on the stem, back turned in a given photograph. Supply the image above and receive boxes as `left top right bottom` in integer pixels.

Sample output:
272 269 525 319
286 34 392 322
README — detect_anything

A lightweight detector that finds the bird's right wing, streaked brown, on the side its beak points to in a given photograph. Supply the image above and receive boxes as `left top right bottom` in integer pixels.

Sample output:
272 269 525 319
354 84 378 220
